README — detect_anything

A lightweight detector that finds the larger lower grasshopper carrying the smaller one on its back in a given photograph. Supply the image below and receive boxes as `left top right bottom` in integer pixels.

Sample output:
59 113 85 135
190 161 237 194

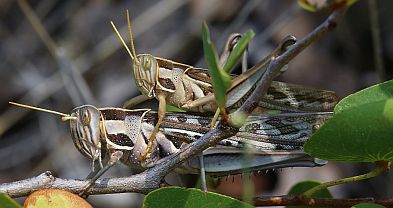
10 102 331 176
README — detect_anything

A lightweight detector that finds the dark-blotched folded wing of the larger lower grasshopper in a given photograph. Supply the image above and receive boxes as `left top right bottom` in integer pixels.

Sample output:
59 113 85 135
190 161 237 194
161 112 331 151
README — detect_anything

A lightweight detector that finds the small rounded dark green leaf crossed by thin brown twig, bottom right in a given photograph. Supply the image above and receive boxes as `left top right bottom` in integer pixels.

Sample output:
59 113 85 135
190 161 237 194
287 181 333 208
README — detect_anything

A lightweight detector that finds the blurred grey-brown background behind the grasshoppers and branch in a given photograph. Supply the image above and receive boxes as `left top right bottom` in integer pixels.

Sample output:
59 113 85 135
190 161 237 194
0 0 393 207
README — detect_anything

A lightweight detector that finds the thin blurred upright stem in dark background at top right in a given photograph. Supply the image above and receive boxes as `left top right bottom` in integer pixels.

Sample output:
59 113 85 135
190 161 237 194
368 0 387 82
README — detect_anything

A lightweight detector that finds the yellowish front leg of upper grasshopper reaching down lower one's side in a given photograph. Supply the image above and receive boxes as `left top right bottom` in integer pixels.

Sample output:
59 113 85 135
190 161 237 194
139 93 166 161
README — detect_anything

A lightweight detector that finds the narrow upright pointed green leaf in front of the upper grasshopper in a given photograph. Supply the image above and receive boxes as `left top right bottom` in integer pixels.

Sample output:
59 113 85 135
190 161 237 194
202 22 231 109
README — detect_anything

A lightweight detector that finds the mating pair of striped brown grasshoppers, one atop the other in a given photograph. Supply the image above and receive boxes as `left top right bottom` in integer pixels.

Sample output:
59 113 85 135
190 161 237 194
9 12 337 195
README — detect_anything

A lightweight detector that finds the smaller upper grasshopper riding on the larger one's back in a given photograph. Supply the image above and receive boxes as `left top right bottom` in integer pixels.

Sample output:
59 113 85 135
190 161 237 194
111 11 337 160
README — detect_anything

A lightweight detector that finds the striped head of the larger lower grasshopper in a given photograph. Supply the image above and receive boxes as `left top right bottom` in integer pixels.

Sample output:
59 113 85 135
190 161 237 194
70 105 103 163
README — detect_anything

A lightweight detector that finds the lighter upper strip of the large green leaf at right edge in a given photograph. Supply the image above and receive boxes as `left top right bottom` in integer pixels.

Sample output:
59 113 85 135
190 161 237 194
334 80 393 113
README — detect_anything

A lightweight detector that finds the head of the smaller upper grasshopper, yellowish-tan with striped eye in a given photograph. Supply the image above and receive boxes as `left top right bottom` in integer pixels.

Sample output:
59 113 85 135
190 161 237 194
133 54 159 98
